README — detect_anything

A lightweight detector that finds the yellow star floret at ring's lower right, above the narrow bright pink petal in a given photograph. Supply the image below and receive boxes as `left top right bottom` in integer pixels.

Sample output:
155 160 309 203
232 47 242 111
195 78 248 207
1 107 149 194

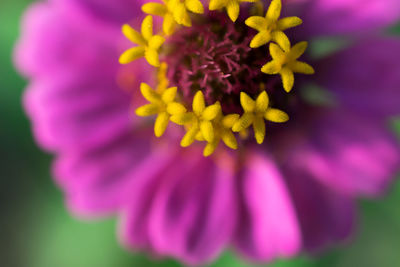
232 91 289 144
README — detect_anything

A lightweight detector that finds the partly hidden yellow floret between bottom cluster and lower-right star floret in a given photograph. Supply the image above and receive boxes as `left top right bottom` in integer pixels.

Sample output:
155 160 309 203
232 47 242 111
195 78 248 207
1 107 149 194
203 113 240 157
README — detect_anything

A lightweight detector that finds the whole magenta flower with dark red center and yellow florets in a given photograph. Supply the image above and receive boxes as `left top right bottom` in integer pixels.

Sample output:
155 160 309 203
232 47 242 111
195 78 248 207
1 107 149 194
15 0 400 264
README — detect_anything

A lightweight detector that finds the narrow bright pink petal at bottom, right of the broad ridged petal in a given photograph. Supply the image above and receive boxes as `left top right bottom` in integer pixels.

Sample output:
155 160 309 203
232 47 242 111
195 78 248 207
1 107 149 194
236 153 301 262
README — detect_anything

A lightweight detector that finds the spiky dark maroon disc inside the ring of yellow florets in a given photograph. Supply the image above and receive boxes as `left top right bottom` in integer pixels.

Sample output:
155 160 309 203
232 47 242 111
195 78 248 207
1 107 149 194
165 12 282 114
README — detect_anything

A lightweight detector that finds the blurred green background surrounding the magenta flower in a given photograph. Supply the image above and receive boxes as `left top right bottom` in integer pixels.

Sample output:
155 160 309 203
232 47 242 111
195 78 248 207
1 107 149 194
0 0 400 267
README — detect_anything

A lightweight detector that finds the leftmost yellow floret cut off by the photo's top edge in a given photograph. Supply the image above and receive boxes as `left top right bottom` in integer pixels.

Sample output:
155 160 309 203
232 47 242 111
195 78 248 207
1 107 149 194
142 0 204 35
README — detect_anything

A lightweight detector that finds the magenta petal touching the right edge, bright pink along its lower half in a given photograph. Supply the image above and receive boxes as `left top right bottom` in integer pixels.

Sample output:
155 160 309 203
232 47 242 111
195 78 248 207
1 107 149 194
291 112 400 196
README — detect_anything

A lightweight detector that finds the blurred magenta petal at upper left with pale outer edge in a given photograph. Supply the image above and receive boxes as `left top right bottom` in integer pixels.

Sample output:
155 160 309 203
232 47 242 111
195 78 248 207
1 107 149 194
15 3 124 77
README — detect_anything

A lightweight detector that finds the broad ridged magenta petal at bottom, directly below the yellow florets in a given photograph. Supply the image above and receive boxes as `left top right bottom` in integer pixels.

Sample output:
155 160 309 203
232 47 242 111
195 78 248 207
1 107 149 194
122 149 236 264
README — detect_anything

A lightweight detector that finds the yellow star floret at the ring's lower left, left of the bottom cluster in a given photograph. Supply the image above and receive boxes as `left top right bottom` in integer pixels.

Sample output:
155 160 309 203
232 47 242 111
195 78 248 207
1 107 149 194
136 83 186 137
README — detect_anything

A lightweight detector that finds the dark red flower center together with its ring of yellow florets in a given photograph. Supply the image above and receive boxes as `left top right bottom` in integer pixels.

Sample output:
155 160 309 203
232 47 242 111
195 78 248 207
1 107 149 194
119 0 314 156
